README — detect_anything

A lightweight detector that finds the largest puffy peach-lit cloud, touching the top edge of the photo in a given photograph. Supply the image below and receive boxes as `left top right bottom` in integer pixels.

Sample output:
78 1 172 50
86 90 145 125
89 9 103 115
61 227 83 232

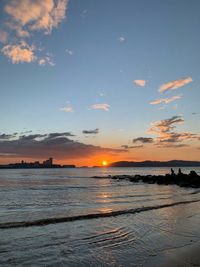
4 0 68 33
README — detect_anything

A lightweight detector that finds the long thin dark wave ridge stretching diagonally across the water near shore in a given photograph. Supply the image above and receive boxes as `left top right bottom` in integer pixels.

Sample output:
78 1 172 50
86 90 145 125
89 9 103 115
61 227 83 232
0 199 200 229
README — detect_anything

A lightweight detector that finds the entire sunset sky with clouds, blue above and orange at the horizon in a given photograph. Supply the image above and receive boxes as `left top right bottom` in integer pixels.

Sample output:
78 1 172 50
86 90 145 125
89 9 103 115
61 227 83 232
0 0 200 166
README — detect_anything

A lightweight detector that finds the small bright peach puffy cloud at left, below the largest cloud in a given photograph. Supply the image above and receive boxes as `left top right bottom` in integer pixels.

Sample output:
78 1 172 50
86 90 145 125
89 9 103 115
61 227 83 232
1 41 36 64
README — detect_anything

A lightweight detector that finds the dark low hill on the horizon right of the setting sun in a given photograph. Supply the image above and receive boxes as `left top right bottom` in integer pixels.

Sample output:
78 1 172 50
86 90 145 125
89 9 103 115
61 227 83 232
109 160 200 167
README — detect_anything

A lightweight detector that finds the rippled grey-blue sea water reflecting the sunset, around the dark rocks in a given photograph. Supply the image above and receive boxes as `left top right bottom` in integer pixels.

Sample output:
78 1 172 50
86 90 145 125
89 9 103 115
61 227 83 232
0 167 200 267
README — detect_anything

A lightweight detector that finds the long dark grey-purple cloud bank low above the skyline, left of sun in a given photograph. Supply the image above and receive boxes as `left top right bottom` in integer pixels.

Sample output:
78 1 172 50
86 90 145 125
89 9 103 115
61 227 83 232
0 132 128 160
